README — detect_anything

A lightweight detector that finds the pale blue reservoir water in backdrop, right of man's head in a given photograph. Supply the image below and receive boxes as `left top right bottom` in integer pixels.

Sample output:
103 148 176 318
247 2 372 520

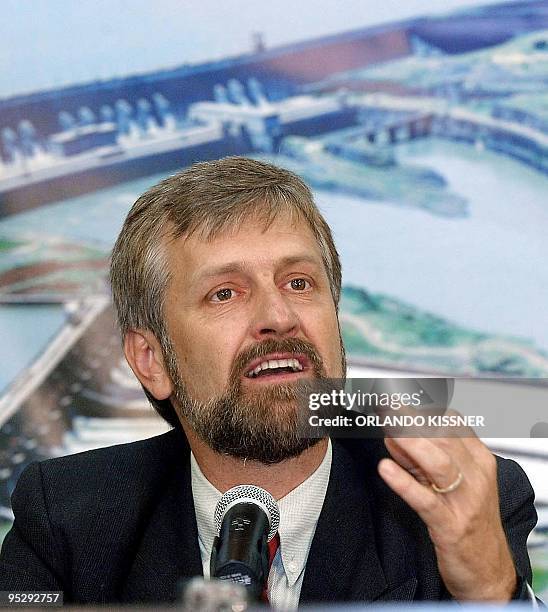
317 139 548 351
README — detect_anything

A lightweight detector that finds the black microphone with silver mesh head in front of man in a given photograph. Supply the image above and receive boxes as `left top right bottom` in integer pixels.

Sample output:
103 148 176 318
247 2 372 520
210 485 280 601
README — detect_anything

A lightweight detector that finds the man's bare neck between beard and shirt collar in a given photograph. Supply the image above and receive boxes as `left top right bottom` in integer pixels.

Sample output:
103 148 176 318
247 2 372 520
182 421 327 499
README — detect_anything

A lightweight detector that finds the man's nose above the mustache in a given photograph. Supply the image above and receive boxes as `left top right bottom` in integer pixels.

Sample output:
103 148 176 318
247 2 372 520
252 287 300 340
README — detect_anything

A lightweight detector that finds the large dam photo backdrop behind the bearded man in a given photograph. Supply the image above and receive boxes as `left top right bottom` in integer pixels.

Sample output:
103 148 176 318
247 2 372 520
0 0 548 593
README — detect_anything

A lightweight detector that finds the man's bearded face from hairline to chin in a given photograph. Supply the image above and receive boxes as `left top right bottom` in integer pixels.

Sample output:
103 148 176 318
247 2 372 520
164 217 345 463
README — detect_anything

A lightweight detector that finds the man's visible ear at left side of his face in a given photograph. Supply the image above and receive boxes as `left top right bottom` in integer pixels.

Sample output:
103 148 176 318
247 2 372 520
124 330 173 400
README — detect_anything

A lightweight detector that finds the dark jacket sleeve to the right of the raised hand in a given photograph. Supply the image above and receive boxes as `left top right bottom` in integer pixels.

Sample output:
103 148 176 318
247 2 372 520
497 457 537 601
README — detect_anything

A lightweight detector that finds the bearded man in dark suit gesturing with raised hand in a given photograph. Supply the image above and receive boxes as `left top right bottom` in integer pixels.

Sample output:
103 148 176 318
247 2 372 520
0 157 536 609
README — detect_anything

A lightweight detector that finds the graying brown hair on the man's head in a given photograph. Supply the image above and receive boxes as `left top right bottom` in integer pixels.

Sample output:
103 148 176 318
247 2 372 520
110 157 341 426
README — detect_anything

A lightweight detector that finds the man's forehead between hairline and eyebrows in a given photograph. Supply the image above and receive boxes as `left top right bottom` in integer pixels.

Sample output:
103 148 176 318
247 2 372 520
168 215 323 278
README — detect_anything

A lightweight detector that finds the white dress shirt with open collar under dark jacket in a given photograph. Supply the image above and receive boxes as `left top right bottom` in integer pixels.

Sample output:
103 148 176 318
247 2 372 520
190 440 332 610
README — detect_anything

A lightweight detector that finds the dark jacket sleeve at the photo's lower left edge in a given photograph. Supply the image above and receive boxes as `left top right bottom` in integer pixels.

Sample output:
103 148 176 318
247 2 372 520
0 463 63 591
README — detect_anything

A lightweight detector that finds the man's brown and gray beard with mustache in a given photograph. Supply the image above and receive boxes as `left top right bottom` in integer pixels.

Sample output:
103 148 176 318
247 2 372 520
164 336 346 464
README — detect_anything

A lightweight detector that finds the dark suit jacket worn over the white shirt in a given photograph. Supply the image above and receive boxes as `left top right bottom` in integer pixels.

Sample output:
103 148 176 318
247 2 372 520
0 430 536 603
